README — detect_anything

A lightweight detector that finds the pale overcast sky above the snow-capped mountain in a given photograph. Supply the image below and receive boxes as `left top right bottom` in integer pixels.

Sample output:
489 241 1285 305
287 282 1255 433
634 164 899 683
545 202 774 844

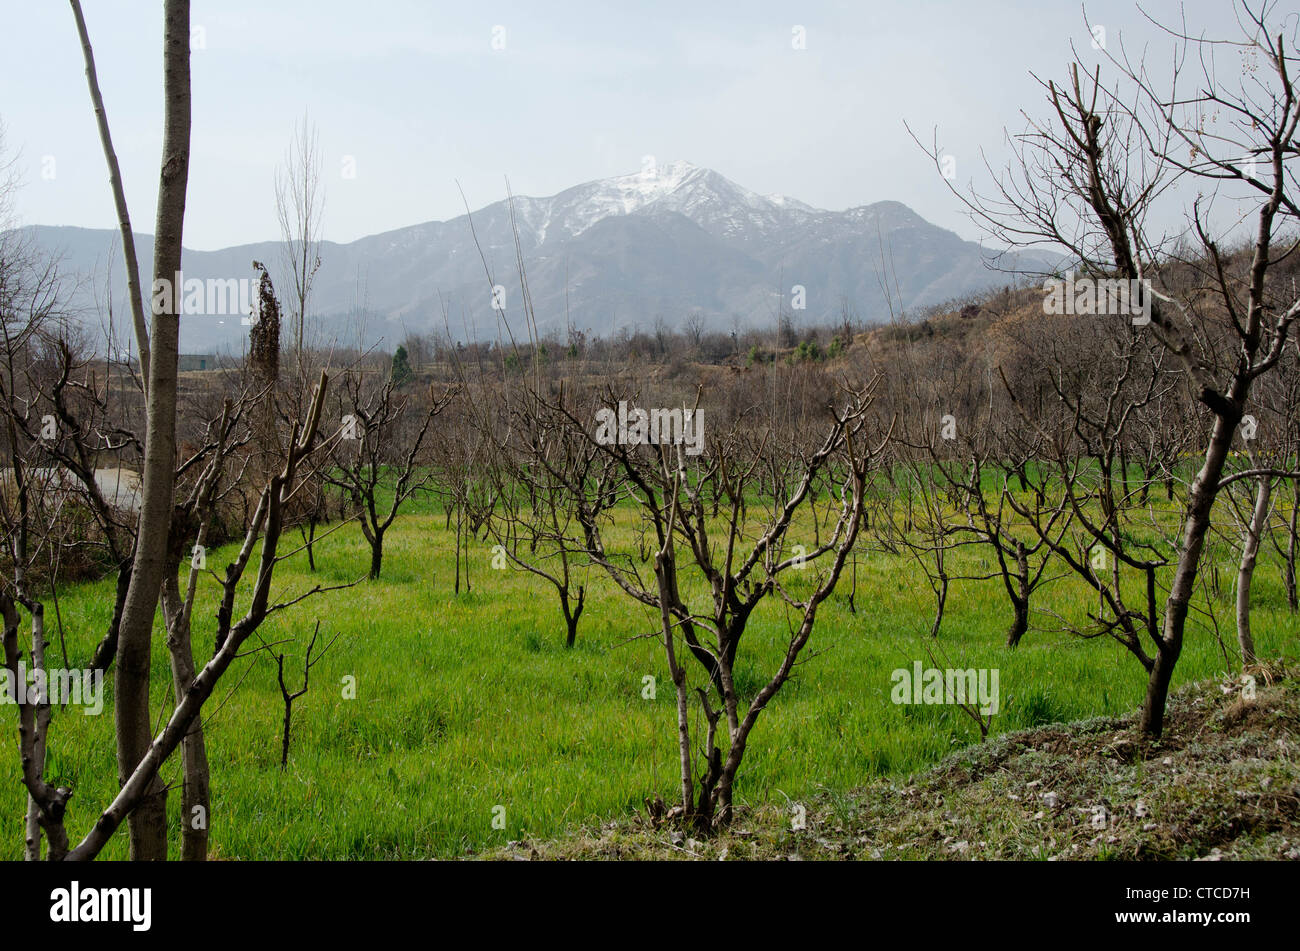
0 0 1258 249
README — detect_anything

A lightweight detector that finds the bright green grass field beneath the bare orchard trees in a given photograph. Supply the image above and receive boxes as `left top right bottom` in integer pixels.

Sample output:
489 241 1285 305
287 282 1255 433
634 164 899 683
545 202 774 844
0 485 1300 859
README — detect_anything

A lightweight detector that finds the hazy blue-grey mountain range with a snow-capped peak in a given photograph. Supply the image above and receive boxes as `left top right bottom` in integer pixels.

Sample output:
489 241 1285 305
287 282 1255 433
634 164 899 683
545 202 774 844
20 161 1055 352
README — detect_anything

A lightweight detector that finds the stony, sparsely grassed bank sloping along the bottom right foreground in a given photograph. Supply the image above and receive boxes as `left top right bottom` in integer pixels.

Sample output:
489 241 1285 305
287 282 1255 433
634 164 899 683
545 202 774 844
499 669 1300 861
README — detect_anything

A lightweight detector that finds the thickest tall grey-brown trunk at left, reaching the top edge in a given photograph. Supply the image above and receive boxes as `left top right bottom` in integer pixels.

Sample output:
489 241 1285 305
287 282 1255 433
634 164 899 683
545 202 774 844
114 0 190 861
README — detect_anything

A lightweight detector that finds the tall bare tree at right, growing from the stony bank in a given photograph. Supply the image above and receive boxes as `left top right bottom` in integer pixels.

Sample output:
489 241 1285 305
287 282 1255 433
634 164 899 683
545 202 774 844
932 1 1300 737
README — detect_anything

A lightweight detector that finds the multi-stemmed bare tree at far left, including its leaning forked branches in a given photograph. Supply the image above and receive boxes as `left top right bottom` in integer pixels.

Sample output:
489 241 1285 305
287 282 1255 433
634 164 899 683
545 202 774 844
41 0 356 860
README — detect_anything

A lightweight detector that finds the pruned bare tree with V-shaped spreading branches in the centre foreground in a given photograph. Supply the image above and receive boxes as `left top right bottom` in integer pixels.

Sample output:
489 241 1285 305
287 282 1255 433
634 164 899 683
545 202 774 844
551 374 888 829
